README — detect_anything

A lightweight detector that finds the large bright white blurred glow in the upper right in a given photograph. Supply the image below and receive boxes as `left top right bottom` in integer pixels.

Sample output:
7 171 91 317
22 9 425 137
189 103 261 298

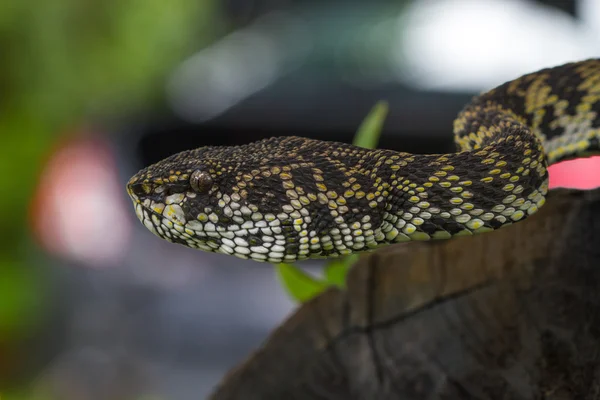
391 0 600 91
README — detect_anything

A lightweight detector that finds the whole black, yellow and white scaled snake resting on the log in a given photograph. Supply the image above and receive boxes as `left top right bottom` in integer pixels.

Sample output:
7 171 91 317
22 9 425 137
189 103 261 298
126 59 600 263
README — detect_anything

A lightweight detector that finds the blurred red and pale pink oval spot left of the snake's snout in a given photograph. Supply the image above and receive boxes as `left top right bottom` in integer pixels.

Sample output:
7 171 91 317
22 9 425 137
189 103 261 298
31 136 131 266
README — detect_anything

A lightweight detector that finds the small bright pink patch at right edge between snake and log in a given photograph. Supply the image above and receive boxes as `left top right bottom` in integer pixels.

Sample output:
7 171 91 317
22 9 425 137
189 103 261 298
548 156 600 189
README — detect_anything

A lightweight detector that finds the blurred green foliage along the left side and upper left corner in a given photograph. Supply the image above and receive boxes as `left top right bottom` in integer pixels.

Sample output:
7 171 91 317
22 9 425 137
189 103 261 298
0 0 220 397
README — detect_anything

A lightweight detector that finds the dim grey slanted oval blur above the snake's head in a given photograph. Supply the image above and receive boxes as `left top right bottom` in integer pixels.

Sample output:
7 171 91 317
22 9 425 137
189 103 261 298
168 13 310 122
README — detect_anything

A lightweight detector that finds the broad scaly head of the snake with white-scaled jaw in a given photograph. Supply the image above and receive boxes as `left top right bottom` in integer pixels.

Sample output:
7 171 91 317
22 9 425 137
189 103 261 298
127 137 378 263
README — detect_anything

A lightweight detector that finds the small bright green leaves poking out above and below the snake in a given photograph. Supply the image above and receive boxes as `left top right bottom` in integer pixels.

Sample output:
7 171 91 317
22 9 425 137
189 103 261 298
275 101 389 303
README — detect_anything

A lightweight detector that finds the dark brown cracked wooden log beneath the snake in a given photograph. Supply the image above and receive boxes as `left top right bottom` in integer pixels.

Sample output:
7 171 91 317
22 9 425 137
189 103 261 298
211 190 600 400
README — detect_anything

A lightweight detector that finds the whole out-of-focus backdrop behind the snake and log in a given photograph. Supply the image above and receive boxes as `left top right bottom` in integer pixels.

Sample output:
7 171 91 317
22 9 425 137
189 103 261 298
0 0 600 400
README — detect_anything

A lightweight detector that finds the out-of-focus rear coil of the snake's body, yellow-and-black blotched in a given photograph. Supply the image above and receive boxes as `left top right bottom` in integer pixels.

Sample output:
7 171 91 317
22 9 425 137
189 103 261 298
454 60 600 165
